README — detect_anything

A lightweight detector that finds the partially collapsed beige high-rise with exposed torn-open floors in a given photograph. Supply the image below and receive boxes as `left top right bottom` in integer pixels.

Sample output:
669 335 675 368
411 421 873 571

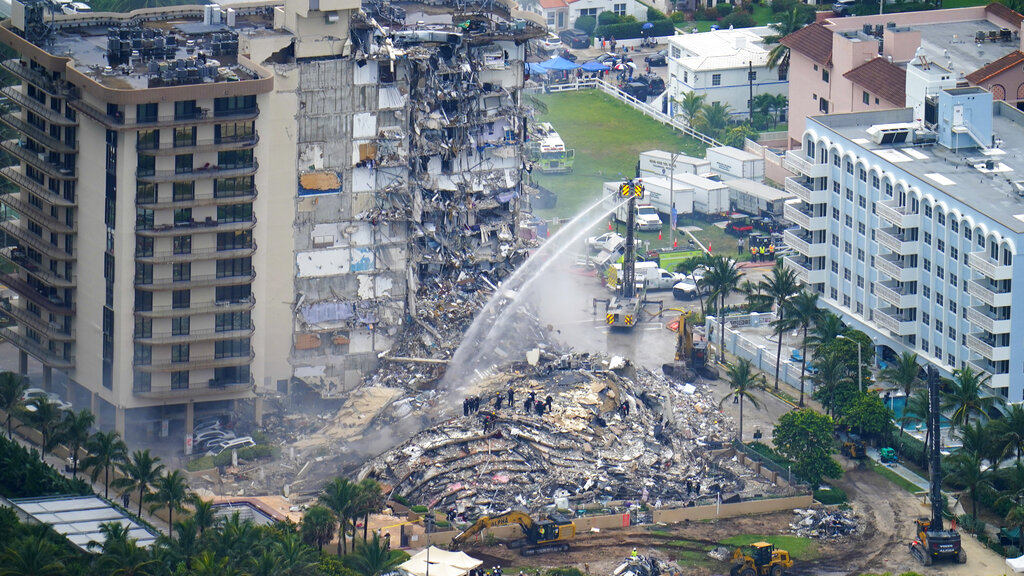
0 0 545 434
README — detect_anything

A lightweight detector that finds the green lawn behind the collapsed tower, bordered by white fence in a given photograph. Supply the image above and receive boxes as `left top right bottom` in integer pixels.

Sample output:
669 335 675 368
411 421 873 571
532 90 707 219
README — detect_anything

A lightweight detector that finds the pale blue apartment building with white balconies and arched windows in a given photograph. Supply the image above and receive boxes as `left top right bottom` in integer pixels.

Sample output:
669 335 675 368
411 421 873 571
785 85 1024 402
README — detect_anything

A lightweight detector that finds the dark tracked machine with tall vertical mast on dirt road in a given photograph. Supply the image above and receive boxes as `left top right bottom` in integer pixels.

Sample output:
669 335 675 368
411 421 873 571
910 366 967 566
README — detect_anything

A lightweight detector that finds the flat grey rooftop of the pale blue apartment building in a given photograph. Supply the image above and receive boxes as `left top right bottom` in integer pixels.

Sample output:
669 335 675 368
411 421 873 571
808 101 1024 234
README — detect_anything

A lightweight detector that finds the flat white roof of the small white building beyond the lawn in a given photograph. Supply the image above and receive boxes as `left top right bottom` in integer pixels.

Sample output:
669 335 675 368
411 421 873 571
669 27 774 71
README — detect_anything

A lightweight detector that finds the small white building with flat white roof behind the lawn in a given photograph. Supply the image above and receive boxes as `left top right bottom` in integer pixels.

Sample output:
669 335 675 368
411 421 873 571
668 27 790 118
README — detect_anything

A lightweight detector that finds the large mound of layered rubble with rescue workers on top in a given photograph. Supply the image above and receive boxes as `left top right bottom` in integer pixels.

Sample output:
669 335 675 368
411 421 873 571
358 354 798 512
